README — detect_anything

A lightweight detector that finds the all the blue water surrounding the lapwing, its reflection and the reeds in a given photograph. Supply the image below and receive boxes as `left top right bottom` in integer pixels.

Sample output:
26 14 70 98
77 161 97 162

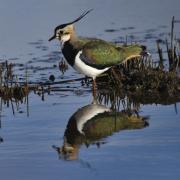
0 0 180 180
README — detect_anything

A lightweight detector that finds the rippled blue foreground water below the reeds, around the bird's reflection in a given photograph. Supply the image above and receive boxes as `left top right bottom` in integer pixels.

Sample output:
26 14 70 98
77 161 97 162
0 94 180 180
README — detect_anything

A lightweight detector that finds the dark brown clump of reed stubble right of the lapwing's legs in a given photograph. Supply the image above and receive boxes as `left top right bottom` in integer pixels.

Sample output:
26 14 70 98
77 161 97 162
97 68 180 109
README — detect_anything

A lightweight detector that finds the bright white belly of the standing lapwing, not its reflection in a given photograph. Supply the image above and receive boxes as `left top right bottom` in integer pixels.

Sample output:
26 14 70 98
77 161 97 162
73 51 110 79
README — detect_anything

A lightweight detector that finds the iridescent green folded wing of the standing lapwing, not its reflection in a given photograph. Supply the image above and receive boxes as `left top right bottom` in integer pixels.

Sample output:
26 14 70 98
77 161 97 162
81 40 142 68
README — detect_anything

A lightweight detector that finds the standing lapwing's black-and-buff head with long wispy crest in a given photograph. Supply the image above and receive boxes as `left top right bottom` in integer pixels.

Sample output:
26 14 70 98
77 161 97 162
49 9 92 42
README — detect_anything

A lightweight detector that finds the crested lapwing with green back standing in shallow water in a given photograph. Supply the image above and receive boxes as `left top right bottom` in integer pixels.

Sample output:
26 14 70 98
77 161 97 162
49 9 146 96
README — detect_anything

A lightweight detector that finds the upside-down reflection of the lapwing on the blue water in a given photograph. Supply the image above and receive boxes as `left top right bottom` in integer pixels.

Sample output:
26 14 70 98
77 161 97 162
53 96 149 160
